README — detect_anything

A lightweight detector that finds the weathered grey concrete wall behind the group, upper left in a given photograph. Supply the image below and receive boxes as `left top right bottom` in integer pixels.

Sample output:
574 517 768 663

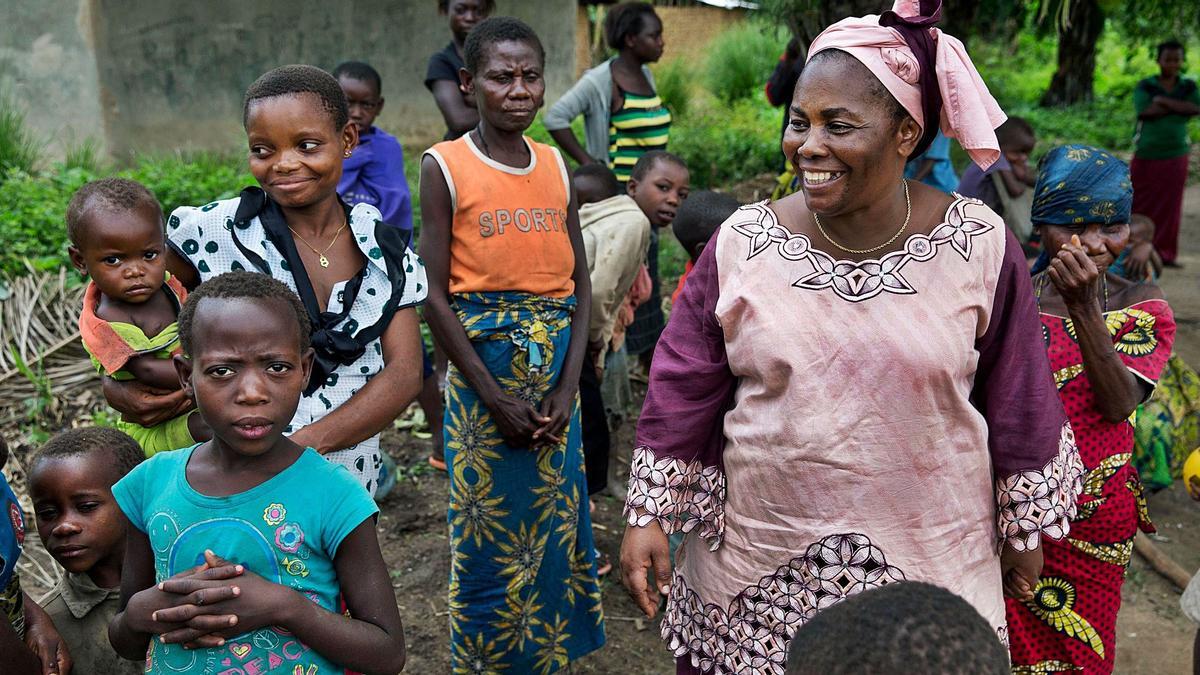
0 0 576 156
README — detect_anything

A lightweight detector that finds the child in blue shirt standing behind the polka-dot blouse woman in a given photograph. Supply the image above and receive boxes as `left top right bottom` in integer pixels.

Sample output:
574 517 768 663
331 61 413 240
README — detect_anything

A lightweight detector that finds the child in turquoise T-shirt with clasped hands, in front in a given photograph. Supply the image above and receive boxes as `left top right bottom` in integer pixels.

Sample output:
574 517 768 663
109 271 404 675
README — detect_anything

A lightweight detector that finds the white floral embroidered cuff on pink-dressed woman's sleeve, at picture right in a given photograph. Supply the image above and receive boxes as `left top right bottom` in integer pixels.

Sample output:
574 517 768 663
996 423 1085 551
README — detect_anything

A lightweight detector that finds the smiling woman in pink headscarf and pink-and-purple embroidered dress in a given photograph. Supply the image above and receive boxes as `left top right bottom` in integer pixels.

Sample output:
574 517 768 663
622 4 1082 675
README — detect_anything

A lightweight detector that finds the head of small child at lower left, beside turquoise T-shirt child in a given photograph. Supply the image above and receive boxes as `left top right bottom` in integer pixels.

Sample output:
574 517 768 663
29 426 145 587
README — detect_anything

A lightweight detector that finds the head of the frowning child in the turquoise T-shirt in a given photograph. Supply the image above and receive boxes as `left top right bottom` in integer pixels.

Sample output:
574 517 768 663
175 271 313 455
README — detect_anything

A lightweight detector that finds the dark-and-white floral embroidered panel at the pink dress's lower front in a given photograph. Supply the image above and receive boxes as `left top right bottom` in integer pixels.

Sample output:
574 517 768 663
661 533 905 675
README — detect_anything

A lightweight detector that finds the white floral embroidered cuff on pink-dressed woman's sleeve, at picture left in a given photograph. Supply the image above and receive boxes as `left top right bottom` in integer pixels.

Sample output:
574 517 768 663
625 446 725 551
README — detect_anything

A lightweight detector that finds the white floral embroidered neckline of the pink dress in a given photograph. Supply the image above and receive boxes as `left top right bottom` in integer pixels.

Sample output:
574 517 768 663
732 195 992 303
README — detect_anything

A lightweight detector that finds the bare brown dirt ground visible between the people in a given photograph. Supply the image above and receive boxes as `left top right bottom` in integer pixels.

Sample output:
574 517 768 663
379 185 1200 675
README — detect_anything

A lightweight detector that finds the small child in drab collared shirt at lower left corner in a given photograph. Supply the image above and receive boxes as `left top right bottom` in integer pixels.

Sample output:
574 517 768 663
29 426 145 675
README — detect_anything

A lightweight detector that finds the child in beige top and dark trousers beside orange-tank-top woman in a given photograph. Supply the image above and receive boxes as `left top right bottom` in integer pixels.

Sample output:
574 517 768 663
574 163 650 511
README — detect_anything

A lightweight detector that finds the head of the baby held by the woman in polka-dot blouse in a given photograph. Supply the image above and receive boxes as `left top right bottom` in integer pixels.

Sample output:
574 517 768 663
66 178 167 305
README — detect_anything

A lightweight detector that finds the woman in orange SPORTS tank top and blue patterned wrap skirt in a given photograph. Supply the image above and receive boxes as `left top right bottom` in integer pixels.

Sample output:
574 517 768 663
421 17 605 673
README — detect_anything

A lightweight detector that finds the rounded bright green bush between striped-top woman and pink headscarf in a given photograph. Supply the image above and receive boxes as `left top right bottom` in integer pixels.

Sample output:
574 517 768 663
704 22 786 102
